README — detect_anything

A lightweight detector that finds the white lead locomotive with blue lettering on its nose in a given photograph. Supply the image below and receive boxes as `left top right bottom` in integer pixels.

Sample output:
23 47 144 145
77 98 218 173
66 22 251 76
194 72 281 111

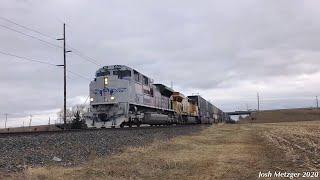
87 65 171 128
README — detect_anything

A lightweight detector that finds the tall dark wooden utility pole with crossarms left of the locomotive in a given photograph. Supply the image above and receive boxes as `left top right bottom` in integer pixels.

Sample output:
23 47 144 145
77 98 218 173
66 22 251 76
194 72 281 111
57 23 71 128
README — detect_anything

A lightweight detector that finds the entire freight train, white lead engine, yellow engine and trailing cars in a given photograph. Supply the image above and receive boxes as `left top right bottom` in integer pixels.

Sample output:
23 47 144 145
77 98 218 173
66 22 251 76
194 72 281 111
86 65 229 128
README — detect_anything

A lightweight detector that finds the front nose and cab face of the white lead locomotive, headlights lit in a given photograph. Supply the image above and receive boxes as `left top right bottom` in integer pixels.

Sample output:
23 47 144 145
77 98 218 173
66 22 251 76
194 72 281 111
90 65 133 127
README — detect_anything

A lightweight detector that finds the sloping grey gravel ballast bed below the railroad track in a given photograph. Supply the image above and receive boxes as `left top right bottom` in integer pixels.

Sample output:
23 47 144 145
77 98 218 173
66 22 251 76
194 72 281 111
0 125 205 172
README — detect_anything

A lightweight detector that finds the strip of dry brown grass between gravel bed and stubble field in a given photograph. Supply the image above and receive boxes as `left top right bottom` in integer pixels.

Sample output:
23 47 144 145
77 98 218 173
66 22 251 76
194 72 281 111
18 125 264 179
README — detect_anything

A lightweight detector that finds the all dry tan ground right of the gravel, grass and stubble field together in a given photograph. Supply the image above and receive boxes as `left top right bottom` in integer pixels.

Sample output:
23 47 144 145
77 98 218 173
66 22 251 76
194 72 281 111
0 121 320 179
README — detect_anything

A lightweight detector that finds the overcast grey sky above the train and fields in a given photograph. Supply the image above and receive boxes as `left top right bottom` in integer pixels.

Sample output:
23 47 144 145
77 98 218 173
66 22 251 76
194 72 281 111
0 0 320 127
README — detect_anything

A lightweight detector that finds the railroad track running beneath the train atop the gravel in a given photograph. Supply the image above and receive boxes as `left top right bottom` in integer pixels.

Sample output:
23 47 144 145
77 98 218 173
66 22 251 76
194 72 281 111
0 124 203 138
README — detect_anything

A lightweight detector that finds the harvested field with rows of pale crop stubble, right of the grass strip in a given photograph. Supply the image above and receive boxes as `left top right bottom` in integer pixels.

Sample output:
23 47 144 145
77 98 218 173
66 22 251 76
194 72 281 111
258 121 320 170
